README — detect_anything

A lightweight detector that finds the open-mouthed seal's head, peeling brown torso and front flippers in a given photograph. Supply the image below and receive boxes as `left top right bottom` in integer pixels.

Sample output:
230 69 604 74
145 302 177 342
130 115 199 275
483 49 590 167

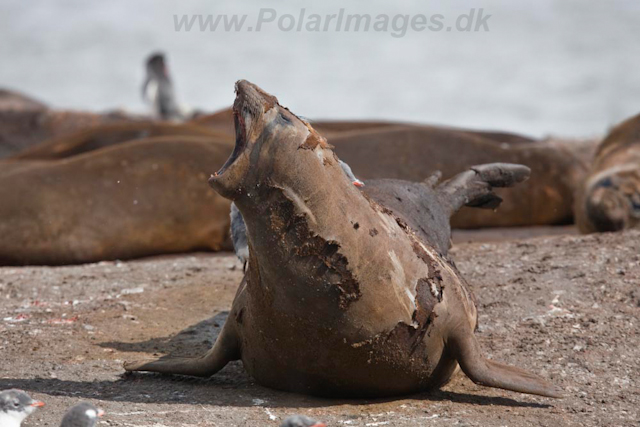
124 81 560 397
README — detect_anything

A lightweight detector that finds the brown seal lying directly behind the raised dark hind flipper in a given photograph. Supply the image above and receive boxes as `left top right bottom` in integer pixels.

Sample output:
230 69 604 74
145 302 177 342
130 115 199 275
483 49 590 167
329 126 588 228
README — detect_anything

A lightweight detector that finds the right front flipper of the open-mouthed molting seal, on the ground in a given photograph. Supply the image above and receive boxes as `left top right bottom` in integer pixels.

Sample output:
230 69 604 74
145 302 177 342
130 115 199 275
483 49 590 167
447 330 562 398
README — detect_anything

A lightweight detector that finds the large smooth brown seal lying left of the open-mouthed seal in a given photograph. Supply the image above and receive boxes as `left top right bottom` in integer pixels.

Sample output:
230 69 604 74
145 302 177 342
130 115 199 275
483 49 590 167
0 136 232 265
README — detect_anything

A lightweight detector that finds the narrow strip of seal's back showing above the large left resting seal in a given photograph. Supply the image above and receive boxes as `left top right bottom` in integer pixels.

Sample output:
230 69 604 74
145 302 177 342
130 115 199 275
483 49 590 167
10 121 233 160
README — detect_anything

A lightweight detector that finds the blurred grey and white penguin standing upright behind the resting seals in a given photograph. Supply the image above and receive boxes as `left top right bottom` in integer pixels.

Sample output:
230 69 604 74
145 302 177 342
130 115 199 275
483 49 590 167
142 53 184 120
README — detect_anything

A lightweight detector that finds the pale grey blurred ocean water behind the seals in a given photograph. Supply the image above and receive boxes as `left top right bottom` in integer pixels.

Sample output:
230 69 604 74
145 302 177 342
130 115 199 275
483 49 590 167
0 0 640 136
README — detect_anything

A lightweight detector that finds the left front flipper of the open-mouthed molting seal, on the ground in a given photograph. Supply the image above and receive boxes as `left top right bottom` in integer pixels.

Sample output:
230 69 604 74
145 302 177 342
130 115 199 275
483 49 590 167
124 324 240 377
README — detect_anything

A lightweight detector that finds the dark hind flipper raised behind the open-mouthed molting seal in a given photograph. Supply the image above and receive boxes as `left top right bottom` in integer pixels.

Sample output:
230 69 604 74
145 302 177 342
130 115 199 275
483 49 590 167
436 163 531 219
